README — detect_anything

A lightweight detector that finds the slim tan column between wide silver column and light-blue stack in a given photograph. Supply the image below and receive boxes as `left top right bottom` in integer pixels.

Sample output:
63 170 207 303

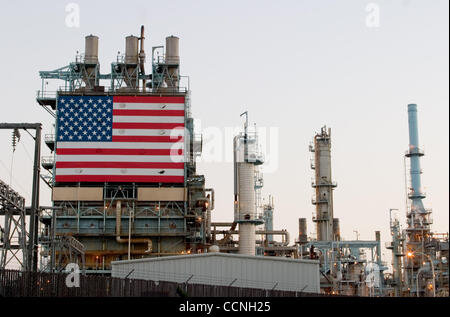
310 127 336 241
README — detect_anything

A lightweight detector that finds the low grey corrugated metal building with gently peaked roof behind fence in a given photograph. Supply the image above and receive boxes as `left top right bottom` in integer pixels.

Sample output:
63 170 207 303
112 254 320 293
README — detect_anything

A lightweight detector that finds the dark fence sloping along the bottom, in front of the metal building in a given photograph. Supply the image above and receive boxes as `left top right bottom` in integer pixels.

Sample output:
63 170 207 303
0 270 326 297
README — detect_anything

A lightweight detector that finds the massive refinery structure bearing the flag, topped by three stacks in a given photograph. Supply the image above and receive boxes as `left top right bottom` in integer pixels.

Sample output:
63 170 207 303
37 27 214 274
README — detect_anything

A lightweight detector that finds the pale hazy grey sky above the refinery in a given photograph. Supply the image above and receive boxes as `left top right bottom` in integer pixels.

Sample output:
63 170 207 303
0 0 449 266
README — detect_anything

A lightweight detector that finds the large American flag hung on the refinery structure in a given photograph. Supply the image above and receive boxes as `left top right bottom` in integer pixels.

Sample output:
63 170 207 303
55 96 185 183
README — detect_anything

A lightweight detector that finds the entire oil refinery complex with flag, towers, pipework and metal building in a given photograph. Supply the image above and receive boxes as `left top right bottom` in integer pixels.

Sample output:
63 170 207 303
0 26 449 297
